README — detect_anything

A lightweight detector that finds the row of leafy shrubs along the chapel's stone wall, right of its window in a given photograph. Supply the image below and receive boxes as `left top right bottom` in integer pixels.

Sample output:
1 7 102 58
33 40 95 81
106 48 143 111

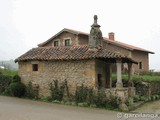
50 80 119 109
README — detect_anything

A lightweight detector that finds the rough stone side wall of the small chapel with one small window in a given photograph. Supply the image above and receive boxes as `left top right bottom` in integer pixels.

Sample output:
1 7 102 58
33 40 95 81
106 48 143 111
19 60 96 97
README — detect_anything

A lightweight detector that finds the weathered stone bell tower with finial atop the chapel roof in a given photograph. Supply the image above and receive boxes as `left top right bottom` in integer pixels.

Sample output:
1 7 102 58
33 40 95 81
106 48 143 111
89 15 103 48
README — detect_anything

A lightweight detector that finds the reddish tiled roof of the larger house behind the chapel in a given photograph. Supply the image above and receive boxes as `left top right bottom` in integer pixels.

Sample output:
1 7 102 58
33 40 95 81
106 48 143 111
38 28 154 54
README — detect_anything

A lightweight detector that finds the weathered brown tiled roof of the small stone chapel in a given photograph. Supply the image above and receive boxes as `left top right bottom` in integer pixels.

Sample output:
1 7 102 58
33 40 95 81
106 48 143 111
15 46 136 63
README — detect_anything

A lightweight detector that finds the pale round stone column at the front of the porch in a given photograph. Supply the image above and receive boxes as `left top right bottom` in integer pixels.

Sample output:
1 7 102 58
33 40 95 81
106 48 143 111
116 59 123 88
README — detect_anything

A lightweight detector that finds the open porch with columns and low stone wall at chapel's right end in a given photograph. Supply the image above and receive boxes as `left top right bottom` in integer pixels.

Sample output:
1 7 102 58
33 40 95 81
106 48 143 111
96 59 135 100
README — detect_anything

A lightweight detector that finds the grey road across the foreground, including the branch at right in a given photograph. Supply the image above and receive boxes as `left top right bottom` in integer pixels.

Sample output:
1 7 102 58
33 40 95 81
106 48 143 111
0 96 160 120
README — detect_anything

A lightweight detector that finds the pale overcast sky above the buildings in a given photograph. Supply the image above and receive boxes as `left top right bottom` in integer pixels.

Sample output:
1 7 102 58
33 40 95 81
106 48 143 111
0 0 160 70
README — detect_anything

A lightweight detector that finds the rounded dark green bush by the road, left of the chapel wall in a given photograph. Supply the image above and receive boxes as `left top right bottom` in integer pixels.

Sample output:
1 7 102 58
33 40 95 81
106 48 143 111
9 82 25 97
